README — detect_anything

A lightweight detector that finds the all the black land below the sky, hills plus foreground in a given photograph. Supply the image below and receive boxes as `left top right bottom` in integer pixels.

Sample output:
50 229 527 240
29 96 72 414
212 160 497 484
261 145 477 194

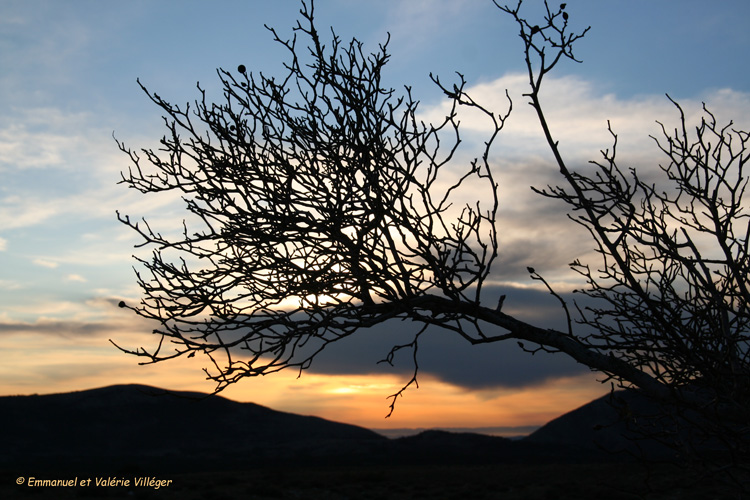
0 385 736 500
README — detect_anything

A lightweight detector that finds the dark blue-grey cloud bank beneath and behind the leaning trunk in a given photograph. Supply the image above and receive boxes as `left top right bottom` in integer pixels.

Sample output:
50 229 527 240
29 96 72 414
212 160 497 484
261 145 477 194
310 287 589 390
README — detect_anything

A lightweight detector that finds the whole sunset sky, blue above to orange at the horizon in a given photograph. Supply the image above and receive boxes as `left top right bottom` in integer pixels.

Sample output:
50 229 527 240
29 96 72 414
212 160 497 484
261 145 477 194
0 0 750 434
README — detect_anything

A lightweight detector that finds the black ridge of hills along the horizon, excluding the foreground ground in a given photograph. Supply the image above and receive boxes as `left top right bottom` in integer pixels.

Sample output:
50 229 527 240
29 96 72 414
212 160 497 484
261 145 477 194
0 385 668 471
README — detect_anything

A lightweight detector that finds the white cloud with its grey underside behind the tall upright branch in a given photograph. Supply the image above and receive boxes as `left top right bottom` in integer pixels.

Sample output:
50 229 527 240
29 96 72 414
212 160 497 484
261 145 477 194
414 74 750 286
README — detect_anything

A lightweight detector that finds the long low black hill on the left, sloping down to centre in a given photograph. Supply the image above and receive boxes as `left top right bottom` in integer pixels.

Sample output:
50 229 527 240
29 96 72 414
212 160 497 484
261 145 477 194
0 385 386 468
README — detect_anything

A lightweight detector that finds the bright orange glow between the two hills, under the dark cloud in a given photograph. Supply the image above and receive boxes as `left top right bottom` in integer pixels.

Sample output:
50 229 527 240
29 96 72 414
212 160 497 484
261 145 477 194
223 373 608 429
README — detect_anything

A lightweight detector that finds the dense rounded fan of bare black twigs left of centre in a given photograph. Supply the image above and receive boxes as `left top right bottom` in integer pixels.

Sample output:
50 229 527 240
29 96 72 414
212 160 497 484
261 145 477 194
118 3 507 412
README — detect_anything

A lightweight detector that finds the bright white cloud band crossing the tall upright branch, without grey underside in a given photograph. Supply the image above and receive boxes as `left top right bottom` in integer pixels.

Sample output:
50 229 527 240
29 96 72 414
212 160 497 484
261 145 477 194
423 74 750 160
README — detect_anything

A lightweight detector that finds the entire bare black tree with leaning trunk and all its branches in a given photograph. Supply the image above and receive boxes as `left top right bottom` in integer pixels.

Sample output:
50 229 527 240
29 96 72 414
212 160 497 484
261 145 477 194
118 1 750 484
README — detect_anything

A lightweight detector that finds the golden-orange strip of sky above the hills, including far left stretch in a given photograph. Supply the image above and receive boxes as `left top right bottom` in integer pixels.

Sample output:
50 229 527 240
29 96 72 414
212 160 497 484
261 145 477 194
0 320 607 429
